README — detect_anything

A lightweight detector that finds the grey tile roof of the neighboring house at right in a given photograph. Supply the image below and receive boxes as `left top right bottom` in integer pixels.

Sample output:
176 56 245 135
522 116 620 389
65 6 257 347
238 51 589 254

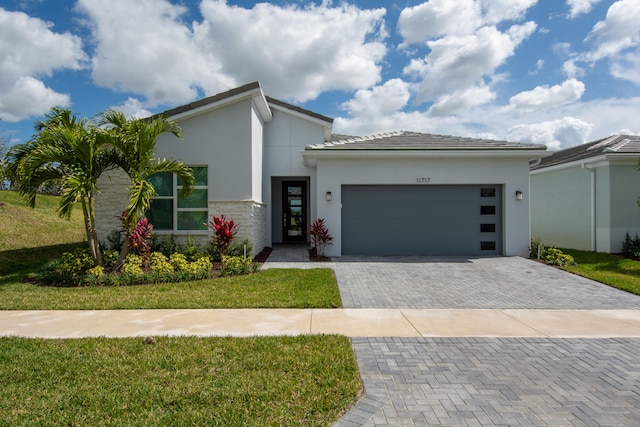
531 135 640 170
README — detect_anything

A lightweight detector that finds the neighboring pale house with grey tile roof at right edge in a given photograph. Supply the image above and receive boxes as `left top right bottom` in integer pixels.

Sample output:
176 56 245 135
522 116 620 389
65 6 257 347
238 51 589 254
531 135 640 253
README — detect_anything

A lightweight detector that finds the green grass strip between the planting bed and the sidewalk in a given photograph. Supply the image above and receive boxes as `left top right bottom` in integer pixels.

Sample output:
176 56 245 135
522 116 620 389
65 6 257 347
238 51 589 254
0 268 342 310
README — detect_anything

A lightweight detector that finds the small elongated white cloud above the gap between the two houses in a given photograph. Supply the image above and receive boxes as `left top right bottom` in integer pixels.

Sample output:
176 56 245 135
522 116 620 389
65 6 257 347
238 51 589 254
506 79 585 111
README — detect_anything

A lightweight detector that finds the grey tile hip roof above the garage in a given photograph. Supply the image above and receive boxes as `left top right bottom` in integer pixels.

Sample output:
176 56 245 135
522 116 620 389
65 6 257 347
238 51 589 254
306 131 546 150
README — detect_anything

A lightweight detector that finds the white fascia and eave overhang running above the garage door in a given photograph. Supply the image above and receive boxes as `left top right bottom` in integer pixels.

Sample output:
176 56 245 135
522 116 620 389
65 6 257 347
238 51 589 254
302 149 552 167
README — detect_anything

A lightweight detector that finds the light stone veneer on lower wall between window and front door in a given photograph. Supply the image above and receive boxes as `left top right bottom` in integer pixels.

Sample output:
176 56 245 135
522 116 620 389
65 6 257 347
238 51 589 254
209 200 267 256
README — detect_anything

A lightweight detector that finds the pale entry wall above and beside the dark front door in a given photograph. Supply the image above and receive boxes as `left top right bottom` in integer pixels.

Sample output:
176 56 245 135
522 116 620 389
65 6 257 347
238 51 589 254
262 108 328 245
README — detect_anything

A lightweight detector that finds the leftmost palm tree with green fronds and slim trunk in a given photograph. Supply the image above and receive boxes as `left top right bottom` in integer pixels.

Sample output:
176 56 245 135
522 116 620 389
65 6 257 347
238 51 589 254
5 107 118 265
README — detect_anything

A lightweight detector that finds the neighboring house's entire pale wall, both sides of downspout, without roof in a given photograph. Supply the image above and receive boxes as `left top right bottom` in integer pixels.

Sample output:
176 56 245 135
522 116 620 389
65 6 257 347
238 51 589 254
531 161 640 253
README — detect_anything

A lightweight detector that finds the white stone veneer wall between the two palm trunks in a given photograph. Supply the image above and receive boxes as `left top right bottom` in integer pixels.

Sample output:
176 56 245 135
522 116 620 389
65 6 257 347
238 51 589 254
95 169 131 242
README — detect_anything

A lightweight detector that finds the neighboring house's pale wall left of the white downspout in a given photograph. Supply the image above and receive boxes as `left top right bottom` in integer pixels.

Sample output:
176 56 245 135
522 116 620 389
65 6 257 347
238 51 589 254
531 166 592 251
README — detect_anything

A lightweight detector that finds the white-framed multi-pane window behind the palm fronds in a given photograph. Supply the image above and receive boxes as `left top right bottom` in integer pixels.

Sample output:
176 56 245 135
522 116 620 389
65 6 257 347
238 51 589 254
147 166 209 231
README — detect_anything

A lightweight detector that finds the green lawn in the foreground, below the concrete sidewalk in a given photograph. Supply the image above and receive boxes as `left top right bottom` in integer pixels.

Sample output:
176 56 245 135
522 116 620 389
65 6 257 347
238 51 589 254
0 335 362 426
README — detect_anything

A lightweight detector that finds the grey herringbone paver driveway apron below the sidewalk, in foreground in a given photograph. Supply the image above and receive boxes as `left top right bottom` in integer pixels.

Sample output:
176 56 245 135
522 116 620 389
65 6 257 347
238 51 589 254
337 338 640 427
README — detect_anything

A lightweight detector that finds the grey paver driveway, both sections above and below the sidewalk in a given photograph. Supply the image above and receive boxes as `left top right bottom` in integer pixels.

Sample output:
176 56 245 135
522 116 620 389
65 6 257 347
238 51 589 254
264 252 640 427
